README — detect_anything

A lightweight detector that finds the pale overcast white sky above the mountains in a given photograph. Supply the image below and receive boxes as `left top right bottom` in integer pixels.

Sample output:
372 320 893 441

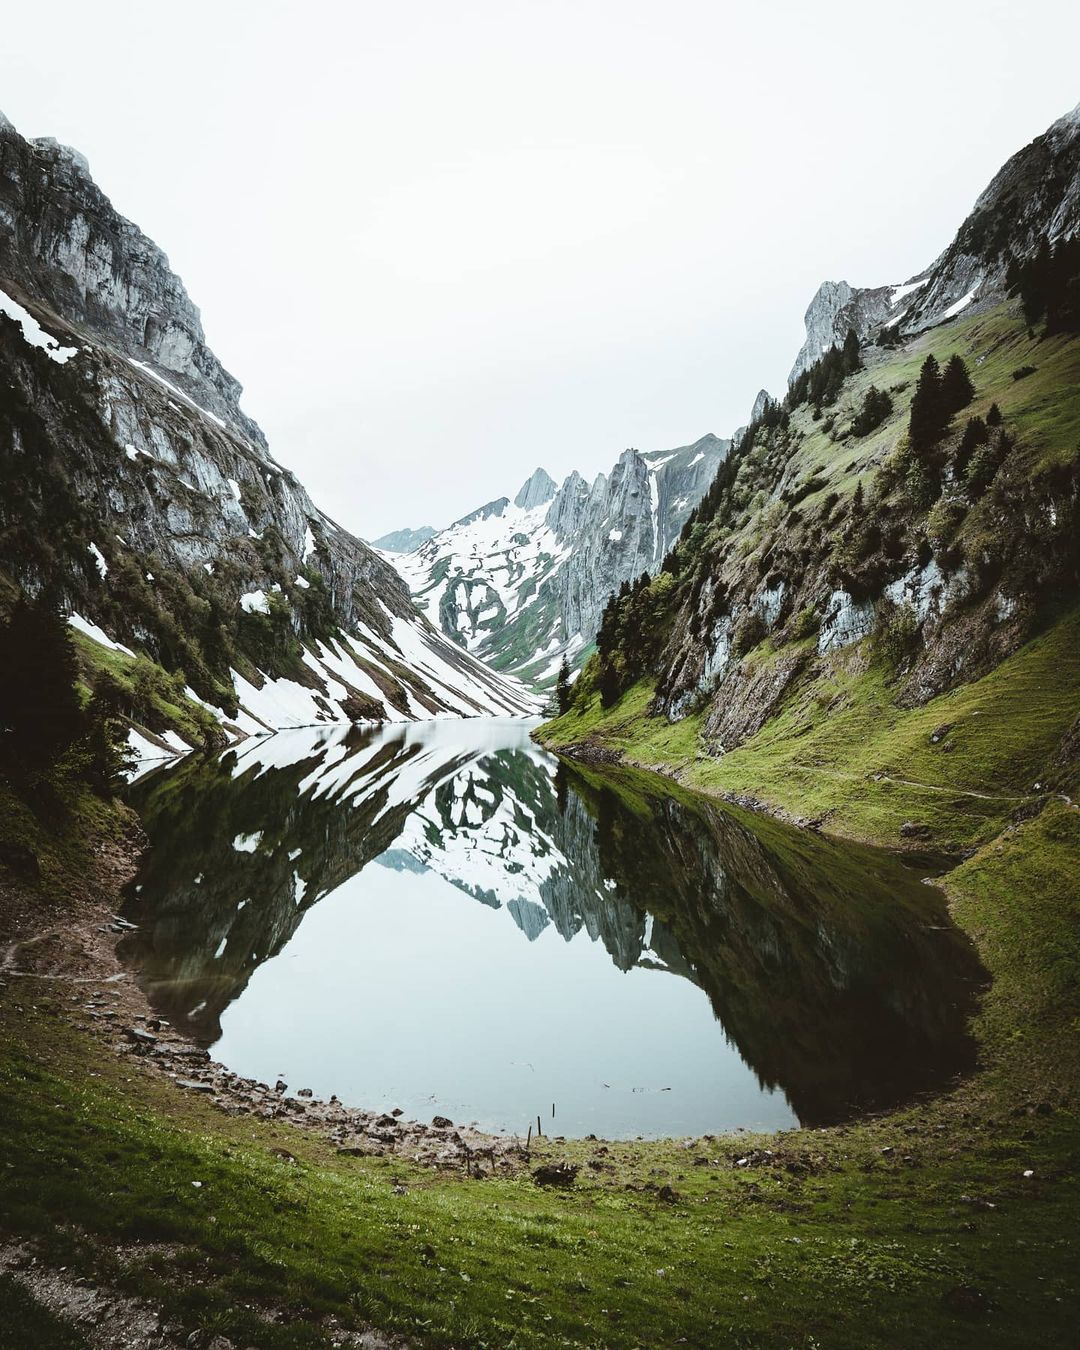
0 0 1080 537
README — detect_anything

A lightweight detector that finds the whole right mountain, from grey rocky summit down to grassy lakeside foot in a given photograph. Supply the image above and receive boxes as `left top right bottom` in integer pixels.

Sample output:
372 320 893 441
548 97 1080 838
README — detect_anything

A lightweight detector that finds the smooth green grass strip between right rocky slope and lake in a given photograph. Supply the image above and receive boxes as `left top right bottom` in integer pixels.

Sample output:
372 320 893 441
540 612 1080 849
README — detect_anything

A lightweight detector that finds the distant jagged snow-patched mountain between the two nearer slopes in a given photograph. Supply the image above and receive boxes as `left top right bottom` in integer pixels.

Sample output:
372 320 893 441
383 435 730 689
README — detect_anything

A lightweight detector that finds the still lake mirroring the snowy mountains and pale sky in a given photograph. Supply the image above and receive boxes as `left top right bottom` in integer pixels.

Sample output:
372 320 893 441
123 721 981 1137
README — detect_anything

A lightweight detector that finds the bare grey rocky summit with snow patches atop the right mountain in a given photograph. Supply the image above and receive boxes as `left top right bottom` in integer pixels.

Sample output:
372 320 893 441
788 104 1080 381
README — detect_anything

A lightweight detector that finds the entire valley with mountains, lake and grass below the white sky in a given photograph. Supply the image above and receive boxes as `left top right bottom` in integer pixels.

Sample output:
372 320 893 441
0 78 1080 1350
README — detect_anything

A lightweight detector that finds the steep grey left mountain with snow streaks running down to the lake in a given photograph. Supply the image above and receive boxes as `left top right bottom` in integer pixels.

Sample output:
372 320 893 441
0 119 533 749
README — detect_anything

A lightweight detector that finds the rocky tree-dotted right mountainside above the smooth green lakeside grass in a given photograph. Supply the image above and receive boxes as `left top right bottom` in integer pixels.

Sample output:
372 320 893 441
564 109 1080 772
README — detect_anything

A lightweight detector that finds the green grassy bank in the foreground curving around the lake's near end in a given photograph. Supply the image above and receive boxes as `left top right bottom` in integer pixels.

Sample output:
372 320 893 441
0 788 1080 1347
